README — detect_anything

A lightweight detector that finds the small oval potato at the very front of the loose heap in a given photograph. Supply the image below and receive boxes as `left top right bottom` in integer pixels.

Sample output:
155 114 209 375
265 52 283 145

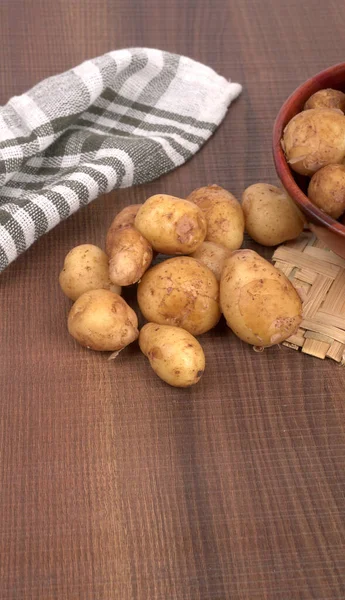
139 323 205 387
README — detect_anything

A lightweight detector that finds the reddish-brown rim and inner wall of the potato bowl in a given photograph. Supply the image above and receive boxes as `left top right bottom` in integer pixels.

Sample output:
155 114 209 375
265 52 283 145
273 62 345 240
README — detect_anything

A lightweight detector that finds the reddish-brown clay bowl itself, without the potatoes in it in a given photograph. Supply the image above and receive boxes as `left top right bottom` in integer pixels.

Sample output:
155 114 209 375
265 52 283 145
273 63 345 258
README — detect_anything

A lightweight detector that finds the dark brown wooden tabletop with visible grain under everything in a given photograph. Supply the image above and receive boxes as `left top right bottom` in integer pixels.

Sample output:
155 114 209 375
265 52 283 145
0 0 345 600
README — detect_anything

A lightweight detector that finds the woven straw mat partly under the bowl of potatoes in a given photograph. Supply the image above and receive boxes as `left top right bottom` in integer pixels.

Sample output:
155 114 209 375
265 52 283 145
272 232 345 365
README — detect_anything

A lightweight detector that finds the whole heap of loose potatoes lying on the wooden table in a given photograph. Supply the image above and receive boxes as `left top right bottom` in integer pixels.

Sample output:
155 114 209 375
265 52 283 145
59 183 304 387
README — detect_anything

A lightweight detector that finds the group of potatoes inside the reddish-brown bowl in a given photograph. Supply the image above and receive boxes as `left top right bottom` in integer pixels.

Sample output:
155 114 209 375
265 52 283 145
282 89 345 220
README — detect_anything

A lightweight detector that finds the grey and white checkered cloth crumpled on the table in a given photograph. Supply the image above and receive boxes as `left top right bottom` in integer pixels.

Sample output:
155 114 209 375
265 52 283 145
0 48 241 271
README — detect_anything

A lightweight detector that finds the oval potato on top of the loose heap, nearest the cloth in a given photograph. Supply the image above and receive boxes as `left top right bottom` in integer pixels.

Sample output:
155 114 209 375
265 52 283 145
135 194 206 254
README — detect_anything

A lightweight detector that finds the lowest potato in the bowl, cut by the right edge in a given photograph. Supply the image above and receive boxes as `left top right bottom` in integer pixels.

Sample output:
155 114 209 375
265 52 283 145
308 165 345 219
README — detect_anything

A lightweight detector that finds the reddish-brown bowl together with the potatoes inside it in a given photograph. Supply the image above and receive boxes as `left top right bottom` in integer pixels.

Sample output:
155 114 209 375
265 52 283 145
273 63 345 258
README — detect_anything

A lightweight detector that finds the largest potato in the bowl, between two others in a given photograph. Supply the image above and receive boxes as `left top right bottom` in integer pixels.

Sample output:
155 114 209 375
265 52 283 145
282 108 345 175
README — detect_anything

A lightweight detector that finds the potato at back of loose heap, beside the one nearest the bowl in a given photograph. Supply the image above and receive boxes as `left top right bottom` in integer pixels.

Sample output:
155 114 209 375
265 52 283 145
187 185 244 250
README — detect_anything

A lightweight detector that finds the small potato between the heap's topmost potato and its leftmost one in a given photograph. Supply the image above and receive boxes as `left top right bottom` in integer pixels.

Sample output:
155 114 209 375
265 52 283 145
109 227 152 286
